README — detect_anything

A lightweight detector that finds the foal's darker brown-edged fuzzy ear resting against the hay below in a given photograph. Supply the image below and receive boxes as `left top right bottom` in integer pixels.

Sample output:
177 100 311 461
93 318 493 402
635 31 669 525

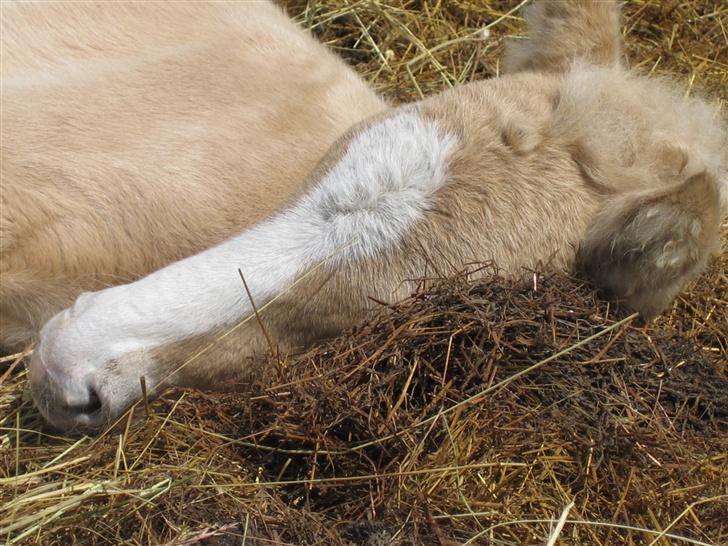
577 173 720 318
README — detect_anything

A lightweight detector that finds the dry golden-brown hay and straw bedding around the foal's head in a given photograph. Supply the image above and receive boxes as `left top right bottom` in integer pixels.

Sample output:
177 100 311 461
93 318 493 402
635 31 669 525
0 0 728 546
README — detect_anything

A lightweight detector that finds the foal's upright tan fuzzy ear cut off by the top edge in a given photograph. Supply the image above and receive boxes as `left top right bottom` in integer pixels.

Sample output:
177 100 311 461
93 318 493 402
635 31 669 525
503 0 622 73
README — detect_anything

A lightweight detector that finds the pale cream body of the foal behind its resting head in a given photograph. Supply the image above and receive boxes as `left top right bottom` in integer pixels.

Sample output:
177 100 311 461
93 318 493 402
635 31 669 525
0 2 384 346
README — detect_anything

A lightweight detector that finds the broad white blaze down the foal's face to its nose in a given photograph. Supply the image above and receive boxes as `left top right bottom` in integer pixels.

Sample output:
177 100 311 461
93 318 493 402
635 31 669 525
35 109 456 382
